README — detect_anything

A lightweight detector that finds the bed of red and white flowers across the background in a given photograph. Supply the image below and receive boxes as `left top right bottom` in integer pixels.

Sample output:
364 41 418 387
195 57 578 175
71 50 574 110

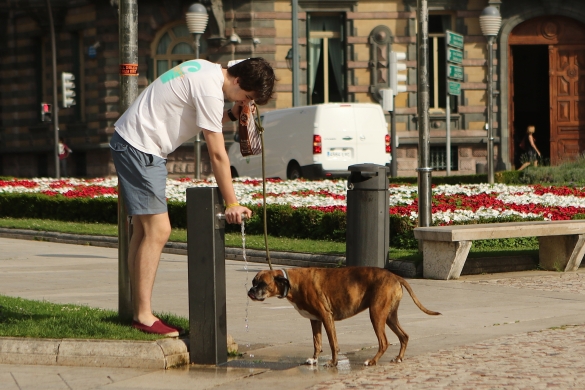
0 177 585 225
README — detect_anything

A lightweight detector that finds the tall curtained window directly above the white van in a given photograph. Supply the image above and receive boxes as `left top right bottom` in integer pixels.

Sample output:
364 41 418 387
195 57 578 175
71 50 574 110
307 14 345 104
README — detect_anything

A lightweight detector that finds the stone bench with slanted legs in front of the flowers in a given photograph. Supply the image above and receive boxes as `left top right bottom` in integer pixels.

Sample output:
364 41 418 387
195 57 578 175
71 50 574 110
414 220 585 280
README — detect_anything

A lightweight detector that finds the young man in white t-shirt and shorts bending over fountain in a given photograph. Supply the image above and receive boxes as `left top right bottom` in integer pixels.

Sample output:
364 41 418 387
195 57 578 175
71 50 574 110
110 58 275 337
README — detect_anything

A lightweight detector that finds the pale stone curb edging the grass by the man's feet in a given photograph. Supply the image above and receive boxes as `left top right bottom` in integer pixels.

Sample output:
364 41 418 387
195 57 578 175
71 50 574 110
0 337 189 369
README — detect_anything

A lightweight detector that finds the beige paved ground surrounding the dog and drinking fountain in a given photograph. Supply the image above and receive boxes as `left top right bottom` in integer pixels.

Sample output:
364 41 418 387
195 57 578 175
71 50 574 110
0 238 585 389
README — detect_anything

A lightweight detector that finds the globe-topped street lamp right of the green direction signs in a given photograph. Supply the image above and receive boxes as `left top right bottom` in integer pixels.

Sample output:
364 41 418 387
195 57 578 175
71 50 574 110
479 6 502 184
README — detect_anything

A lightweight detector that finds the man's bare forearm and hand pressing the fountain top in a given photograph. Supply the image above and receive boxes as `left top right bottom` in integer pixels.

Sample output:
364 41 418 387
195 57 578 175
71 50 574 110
203 129 252 223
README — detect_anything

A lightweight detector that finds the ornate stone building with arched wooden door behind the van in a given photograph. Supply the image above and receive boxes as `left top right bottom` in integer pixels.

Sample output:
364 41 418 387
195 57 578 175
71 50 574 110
0 0 585 177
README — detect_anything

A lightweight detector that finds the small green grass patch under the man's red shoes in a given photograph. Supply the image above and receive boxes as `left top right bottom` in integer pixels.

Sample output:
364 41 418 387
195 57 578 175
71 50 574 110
0 295 189 340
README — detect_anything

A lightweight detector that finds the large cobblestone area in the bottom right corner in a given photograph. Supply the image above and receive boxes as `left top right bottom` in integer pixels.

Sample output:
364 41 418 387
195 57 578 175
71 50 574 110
312 325 585 390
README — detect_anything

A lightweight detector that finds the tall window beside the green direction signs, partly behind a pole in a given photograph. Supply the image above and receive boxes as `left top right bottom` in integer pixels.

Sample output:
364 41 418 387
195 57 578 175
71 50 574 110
429 14 455 113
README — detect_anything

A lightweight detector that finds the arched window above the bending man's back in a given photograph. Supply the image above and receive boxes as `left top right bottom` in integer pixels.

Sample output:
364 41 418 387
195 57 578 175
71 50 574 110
150 22 207 81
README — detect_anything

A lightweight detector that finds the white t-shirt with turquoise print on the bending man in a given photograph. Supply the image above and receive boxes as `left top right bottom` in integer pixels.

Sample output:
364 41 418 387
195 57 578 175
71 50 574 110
114 60 224 158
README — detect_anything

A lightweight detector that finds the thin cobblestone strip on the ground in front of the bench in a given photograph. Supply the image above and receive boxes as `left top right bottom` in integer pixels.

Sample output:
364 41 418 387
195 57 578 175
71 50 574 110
462 272 585 294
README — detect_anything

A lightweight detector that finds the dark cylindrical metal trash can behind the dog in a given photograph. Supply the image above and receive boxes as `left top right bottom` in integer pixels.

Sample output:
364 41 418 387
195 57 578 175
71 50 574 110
346 164 390 268
